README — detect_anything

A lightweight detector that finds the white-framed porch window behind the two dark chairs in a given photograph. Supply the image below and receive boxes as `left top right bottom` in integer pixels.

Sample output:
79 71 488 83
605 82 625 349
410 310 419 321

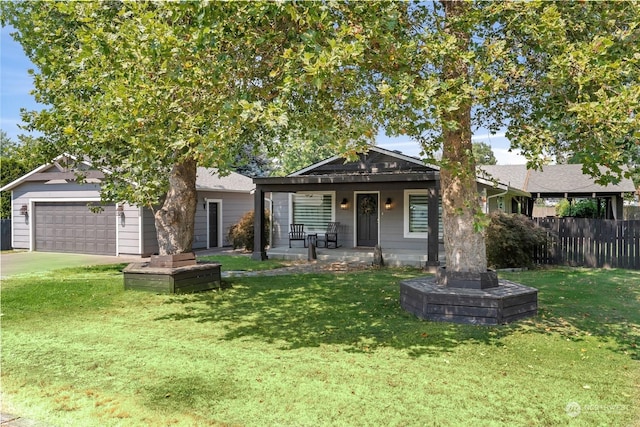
291 193 334 232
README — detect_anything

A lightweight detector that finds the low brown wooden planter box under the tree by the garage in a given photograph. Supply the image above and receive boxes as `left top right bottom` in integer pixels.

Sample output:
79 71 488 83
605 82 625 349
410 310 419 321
123 262 222 294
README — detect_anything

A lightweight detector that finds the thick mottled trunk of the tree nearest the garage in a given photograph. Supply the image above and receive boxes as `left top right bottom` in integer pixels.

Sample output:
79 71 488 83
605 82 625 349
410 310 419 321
154 160 198 255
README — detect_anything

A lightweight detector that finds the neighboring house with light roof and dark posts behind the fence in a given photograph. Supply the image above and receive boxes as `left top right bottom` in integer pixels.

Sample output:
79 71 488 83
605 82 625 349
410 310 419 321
480 165 635 219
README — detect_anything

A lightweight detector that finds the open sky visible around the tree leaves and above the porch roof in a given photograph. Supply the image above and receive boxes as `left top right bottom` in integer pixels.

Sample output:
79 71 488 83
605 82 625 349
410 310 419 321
0 23 525 165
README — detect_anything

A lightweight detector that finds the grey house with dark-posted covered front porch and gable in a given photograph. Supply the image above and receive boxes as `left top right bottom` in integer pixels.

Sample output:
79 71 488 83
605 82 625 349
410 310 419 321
254 147 530 265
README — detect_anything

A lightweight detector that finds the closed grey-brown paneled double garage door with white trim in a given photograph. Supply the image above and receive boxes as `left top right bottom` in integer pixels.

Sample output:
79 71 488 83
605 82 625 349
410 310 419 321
34 202 116 255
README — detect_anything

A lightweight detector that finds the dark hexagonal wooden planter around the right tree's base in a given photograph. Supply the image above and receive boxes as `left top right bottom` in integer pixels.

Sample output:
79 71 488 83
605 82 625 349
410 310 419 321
400 273 538 325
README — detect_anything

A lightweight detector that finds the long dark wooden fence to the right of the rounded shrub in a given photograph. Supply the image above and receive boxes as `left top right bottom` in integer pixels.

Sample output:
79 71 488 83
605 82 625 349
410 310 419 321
534 218 640 270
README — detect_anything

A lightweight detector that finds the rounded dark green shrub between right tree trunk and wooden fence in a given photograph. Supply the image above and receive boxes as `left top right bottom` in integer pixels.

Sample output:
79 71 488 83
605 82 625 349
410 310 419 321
486 212 547 268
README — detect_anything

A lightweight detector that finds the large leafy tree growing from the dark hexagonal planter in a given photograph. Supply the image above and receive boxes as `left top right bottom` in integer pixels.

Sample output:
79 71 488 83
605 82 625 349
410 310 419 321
378 0 640 272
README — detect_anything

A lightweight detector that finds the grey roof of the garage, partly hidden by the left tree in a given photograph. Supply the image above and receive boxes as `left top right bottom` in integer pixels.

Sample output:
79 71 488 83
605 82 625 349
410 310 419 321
0 154 255 193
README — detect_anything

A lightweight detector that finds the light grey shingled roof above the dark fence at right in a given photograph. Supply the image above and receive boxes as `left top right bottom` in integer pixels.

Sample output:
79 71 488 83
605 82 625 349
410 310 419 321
480 164 635 197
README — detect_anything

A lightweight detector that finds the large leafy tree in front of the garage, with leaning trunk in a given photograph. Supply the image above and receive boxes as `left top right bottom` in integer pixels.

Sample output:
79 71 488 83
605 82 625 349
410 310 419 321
2 1 395 254
